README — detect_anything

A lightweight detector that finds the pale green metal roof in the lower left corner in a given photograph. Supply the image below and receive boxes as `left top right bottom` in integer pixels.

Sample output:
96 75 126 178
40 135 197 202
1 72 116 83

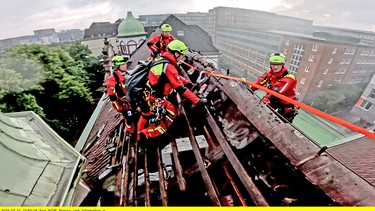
0 111 84 206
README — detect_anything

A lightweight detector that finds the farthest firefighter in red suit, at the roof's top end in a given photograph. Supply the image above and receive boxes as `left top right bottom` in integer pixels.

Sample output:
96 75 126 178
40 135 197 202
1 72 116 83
147 24 175 58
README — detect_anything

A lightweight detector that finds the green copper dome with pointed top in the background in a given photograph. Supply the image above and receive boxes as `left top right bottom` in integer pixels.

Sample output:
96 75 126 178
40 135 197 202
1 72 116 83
117 11 147 37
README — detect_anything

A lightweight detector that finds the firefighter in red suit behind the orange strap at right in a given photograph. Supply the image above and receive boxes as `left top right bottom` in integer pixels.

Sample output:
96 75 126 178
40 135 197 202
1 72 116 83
251 53 297 122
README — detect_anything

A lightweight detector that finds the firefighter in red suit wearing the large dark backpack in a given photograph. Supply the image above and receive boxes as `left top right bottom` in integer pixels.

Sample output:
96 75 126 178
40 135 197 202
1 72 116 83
138 40 200 140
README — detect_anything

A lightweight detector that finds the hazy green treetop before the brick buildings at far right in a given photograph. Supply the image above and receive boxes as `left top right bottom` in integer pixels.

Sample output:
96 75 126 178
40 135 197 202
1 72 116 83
304 84 363 113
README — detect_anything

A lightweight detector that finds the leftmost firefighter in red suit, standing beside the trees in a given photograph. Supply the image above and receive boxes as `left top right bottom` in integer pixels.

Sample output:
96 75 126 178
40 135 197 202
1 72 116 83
106 56 136 133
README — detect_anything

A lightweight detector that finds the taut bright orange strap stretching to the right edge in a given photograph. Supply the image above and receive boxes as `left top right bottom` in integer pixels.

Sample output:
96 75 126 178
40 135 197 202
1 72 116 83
205 72 375 139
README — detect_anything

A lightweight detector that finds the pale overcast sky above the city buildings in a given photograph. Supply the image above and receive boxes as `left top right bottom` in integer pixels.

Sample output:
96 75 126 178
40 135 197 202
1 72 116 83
0 0 375 39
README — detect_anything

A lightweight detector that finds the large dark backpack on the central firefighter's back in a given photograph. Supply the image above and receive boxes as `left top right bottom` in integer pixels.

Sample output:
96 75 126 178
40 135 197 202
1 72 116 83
125 58 169 106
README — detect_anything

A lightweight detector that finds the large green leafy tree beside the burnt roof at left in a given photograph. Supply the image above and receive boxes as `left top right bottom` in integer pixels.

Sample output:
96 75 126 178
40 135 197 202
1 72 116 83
0 45 97 141
